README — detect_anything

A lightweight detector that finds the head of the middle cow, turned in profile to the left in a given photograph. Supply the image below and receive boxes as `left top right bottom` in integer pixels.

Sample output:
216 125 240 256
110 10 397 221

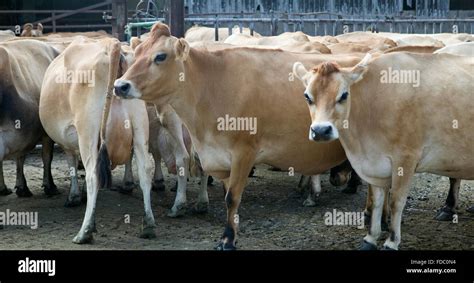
114 23 190 104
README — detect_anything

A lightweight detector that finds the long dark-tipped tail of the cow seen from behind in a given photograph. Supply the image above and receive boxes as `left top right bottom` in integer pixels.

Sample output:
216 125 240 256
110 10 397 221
96 40 120 188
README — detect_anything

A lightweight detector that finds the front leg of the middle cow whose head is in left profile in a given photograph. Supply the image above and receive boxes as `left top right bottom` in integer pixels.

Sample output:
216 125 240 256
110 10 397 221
217 149 255 250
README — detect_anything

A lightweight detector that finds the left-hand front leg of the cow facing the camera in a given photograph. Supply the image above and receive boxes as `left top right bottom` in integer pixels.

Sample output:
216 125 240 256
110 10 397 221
360 184 385 250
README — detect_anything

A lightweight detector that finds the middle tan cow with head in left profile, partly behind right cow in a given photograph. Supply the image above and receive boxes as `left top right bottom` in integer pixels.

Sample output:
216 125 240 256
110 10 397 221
114 23 360 250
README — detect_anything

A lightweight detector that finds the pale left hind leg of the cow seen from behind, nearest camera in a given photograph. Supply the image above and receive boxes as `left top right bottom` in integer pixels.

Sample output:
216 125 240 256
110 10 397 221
72 133 99 244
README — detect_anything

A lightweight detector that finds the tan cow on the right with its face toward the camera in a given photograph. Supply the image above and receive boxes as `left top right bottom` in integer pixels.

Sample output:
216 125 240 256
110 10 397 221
293 52 474 250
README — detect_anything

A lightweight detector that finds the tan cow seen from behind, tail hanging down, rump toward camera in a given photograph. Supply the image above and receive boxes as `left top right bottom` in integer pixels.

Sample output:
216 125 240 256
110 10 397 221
39 37 156 244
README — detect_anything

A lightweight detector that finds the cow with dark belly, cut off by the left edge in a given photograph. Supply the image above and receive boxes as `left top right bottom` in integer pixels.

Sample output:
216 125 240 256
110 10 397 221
0 40 59 200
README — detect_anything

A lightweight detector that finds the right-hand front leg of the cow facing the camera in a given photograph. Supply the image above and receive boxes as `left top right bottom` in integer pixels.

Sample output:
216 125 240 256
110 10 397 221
383 164 415 250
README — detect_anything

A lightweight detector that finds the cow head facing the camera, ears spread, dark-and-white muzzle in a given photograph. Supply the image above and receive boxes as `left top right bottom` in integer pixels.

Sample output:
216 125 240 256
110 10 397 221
293 54 371 142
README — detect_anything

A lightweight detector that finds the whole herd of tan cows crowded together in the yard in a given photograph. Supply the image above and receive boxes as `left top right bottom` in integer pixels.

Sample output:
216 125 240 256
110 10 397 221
0 23 474 250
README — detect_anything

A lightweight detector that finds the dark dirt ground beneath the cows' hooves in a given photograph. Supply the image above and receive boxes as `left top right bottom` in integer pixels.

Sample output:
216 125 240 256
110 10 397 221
0 150 474 250
